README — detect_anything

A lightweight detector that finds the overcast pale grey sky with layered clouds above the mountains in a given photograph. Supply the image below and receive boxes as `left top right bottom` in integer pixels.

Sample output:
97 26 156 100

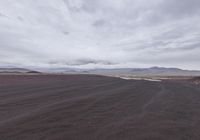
0 0 200 70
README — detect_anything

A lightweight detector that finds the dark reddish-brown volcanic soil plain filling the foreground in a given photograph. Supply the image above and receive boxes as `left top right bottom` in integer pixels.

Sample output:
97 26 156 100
0 75 200 140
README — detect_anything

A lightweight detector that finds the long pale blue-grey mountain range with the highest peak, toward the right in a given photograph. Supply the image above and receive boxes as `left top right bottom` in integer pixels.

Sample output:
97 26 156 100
52 67 200 76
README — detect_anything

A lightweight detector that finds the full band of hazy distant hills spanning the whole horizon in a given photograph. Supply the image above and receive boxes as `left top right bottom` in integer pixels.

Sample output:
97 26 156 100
0 67 200 76
